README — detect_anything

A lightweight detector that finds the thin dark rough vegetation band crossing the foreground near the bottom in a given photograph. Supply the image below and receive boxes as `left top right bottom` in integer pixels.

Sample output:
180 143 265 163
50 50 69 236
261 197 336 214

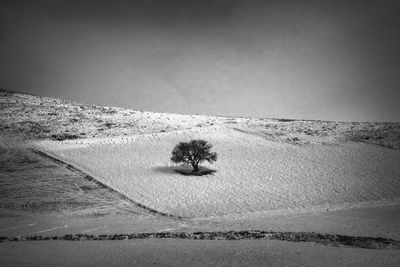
0 231 400 249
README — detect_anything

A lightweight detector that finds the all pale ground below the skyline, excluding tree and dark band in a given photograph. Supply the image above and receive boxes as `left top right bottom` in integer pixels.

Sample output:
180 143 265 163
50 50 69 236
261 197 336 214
0 92 400 266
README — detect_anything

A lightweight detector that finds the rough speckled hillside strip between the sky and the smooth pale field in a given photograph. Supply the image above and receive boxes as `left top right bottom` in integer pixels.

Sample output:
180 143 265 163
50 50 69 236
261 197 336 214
0 90 400 149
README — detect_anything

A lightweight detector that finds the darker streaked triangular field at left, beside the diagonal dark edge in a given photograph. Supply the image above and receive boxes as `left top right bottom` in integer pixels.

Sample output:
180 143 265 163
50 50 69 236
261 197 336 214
0 148 147 216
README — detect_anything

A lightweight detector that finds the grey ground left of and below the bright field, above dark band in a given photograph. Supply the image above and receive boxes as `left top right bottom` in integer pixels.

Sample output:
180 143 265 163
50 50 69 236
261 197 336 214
0 132 400 240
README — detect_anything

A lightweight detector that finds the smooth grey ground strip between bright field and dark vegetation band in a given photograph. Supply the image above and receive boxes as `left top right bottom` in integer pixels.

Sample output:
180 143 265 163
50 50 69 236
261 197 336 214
0 205 400 240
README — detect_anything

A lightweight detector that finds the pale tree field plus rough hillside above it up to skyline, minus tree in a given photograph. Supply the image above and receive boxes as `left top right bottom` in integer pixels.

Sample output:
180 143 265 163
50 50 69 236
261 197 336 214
0 91 400 221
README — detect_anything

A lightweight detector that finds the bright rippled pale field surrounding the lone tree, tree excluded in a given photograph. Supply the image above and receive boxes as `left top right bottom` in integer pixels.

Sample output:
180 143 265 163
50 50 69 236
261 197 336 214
35 126 400 219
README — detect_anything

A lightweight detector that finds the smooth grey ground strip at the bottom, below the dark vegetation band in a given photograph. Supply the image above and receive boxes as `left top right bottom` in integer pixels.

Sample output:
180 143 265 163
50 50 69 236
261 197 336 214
0 239 400 267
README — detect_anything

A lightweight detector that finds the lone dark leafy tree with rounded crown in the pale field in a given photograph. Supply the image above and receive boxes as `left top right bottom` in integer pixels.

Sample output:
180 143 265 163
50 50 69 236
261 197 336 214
171 140 217 172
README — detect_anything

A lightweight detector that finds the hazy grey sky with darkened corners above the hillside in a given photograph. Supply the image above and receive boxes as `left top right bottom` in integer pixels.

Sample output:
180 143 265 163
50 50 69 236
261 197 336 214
0 0 400 121
